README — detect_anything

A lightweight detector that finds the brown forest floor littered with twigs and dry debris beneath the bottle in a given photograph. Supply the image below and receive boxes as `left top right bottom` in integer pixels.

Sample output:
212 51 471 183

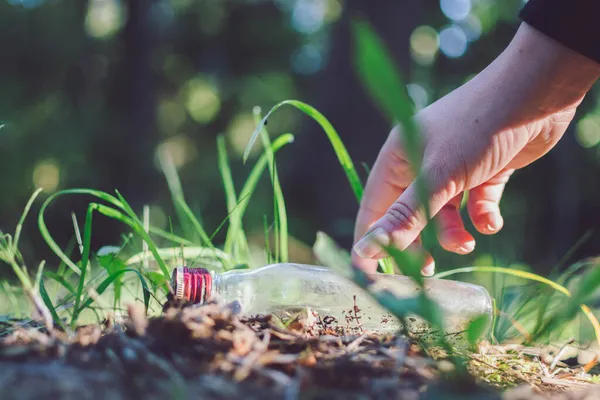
0 302 600 400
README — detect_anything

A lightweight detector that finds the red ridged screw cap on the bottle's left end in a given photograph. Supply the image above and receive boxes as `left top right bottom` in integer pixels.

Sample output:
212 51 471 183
171 267 212 304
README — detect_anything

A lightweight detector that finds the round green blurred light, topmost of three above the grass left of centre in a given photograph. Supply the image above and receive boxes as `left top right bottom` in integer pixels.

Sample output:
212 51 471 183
184 77 221 124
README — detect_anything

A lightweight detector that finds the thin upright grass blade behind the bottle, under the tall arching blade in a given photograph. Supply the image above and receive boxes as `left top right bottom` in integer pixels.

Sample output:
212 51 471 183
253 107 289 263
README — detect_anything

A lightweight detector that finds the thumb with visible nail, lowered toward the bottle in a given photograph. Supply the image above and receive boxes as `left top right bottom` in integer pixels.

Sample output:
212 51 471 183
354 169 460 259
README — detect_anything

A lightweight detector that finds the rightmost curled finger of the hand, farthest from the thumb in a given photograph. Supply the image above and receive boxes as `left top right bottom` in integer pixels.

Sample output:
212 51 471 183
467 169 514 235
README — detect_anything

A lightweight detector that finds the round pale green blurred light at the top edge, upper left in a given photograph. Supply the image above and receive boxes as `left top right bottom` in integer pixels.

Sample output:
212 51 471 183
85 0 126 39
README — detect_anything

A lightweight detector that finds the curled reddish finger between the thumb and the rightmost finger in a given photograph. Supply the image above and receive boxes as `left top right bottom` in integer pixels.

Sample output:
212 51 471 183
436 193 475 254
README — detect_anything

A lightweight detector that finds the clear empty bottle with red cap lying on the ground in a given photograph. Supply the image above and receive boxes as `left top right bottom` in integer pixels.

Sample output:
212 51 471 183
172 263 492 340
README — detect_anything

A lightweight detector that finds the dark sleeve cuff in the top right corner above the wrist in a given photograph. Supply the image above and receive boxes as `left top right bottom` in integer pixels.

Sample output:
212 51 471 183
519 0 600 63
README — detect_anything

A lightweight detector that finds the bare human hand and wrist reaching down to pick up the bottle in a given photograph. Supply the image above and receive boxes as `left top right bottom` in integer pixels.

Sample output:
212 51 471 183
352 24 600 275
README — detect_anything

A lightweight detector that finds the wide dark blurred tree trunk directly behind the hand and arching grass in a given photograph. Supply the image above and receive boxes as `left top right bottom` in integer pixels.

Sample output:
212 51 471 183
280 0 425 247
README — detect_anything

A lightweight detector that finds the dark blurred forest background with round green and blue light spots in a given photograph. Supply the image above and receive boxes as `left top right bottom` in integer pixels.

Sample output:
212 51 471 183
0 0 600 280
